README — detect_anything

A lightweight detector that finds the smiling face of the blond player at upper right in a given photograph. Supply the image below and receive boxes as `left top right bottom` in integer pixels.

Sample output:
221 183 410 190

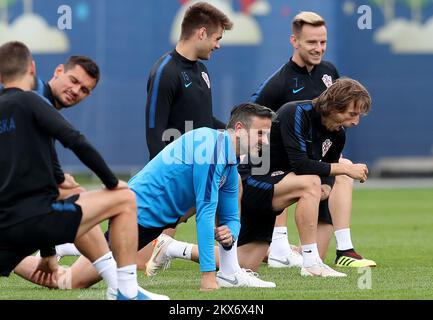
290 24 327 67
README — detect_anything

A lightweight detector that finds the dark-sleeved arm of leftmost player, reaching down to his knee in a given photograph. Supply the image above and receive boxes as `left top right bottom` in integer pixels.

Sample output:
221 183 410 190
27 92 119 189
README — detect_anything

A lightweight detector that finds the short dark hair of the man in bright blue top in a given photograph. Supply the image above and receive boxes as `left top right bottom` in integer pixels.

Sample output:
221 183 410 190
227 102 275 129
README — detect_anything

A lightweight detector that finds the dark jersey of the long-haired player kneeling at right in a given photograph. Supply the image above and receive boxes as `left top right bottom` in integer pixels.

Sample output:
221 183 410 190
270 100 346 185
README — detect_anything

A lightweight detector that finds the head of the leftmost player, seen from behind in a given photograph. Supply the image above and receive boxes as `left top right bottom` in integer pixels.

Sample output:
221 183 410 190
0 41 33 82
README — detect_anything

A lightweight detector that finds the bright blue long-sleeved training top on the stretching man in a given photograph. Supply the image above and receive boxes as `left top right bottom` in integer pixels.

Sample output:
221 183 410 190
129 128 240 272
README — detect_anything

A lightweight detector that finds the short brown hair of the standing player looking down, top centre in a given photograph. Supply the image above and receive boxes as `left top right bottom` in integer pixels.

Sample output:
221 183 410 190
180 2 233 40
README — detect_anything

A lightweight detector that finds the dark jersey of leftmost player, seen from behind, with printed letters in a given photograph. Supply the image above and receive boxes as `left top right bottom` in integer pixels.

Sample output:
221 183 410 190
0 88 118 229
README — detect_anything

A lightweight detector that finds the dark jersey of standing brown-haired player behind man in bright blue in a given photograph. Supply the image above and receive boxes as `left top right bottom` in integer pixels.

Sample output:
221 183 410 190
146 50 224 159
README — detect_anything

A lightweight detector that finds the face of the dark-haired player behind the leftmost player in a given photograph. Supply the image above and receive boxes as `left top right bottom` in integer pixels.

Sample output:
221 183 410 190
49 65 96 108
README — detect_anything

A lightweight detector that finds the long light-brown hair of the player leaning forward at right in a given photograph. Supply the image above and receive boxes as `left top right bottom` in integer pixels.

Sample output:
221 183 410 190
313 77 371 117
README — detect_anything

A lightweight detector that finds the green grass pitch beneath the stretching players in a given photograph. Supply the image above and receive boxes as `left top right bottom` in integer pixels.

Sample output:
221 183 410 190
0 189 433 300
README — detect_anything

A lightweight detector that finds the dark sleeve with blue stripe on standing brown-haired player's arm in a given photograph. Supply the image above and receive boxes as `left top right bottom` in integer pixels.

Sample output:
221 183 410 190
146 60 178 159
